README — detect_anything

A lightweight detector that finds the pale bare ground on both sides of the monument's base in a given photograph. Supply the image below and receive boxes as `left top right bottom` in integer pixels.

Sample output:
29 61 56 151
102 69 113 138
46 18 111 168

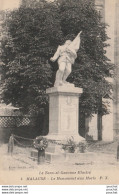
0 141 119 170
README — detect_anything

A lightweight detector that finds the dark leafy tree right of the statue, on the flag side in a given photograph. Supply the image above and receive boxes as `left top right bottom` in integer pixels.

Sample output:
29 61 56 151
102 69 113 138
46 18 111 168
56 0 114 115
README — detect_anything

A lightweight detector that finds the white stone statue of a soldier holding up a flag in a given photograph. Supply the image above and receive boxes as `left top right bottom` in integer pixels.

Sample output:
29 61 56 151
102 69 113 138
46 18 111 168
50 31 82 86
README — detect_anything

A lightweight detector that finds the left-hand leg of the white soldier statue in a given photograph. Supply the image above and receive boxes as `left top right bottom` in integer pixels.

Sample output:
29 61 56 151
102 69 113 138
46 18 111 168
54 62 66 86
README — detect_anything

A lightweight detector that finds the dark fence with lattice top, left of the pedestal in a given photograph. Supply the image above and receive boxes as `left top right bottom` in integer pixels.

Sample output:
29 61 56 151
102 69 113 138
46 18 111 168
0 116 43 143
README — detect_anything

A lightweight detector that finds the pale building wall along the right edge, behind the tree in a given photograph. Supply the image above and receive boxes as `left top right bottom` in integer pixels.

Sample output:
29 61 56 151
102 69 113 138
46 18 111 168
95 0 119 136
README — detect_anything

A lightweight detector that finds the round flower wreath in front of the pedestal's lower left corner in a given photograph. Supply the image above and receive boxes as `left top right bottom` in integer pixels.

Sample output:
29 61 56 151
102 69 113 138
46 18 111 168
33 136 48 150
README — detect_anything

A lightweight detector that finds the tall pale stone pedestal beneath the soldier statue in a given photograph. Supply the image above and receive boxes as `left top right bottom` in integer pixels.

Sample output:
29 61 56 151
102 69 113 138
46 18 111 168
46 84 84 160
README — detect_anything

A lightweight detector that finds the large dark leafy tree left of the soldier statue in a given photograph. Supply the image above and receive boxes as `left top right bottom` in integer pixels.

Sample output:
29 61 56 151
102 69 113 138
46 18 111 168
2 3 62 112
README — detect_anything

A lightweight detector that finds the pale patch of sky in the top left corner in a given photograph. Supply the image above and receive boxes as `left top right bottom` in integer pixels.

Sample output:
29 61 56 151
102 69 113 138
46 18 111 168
0 0 20 10
